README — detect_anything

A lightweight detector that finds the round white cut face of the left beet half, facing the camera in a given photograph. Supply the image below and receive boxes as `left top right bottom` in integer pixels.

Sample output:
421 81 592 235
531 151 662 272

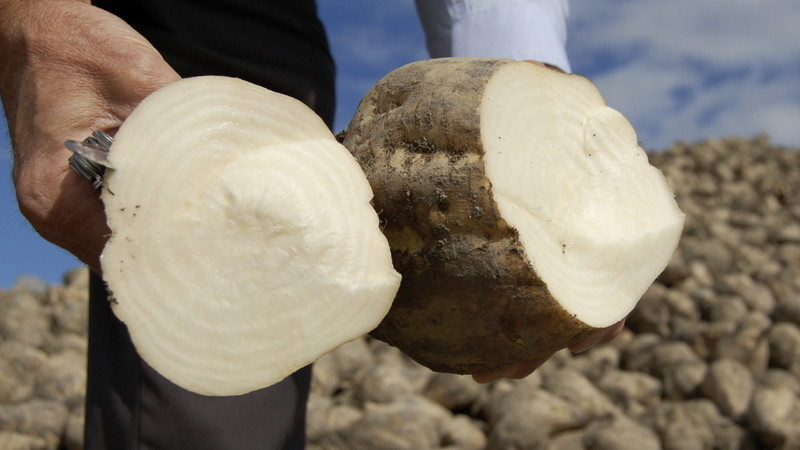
101 77 400 395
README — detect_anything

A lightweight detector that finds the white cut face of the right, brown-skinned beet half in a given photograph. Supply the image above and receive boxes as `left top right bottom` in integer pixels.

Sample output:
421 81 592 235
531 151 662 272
481 64 684 327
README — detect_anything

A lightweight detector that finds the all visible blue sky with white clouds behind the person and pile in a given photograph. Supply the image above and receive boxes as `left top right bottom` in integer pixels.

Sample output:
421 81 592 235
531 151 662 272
0 0 800 289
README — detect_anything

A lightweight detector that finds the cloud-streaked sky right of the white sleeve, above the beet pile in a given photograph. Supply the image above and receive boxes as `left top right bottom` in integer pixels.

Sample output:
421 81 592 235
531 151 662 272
568 0 800 148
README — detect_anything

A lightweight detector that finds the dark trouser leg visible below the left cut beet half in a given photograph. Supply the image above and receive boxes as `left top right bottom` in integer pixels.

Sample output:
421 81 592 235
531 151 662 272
84 274 311 450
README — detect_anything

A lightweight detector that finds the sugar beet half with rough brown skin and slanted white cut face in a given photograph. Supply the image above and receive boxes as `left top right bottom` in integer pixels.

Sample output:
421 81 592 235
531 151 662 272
344 58 684 373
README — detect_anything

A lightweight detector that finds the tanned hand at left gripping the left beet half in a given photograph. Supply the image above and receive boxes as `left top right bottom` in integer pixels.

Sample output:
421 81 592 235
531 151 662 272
0 0 180 273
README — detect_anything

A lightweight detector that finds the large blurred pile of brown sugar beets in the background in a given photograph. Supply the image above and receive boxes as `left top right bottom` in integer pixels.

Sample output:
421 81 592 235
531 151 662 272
0 137 800 450
